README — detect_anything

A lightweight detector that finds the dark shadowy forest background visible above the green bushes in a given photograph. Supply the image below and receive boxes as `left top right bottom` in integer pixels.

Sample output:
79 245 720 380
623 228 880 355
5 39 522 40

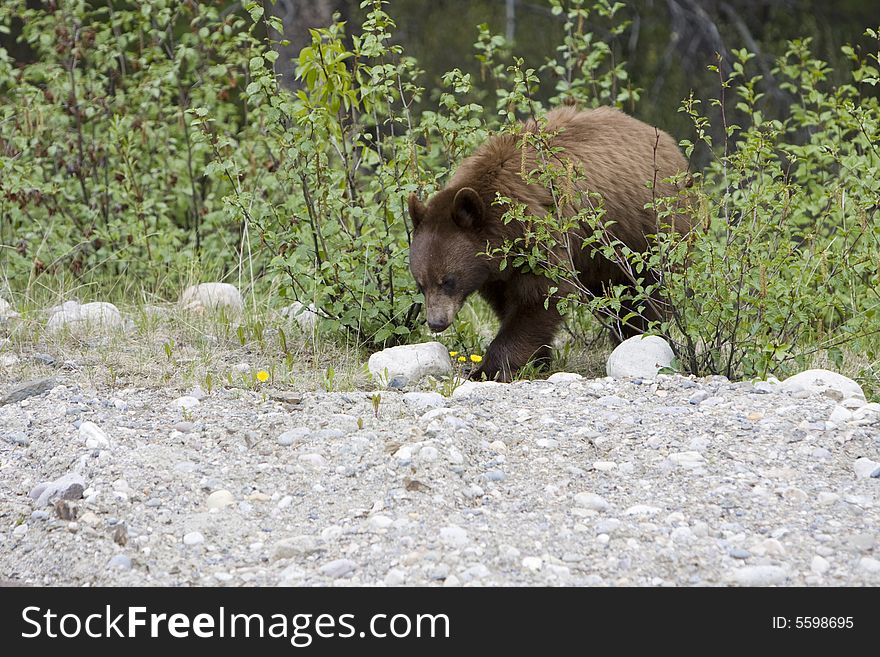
0 0 880 140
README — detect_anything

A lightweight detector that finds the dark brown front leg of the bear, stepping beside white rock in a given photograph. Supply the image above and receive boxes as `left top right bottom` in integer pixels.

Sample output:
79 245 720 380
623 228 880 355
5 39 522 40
471 304 562 383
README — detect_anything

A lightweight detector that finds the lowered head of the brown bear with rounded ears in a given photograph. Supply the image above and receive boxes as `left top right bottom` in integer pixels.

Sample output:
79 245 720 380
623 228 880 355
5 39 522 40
409 187 498 333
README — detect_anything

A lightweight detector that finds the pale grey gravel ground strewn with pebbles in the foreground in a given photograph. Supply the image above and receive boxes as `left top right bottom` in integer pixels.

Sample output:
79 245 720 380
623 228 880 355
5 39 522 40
0 366 880 586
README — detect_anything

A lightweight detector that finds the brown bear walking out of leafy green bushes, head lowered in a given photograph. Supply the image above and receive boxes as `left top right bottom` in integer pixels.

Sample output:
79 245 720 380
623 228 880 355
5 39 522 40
409 107 687 381
